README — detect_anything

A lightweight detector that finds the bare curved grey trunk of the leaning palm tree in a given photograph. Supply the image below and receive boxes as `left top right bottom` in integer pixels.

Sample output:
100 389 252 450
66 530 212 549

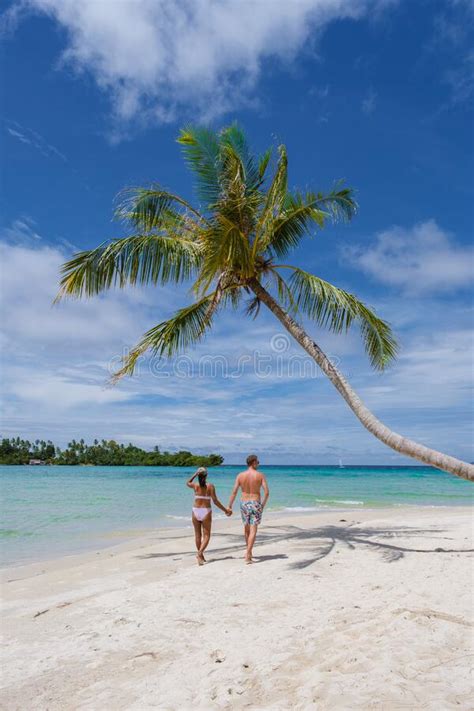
248 279 474 481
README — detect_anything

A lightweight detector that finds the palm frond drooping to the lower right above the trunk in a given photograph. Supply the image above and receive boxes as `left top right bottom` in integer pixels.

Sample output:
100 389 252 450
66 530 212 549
289 267 398 370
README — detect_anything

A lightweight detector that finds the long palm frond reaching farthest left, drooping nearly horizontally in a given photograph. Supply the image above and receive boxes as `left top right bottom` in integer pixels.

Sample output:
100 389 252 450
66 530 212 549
55 234 202 301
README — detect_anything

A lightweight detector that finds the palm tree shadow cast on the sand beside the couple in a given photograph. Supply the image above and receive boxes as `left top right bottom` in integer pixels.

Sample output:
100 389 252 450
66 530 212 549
137 524 474 570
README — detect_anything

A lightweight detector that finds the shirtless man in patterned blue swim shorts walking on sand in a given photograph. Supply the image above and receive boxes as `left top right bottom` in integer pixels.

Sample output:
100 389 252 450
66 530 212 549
228 454 270 564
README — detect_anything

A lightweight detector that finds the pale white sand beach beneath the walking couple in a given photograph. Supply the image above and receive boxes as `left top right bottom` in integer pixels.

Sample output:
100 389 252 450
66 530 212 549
1 507 474 711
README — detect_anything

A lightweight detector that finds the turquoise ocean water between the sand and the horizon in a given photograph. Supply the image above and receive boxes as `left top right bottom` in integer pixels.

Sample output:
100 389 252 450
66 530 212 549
0 466 474 566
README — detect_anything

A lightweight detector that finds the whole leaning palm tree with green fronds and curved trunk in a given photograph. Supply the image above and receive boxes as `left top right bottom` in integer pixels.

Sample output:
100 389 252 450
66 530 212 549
53 125 474 480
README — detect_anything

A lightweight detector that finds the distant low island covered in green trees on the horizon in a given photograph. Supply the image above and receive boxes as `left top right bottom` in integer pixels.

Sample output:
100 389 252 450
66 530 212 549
0 437 224 467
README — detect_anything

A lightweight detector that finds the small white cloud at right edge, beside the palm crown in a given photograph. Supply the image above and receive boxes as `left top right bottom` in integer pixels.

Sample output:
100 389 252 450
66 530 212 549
343 220 474 295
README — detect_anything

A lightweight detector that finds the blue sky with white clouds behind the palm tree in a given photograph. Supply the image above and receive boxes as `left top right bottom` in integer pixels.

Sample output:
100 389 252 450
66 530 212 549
0 0 474 464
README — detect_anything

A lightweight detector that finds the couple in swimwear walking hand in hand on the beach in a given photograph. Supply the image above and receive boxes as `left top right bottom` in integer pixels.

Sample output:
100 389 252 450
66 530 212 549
186 454 270 565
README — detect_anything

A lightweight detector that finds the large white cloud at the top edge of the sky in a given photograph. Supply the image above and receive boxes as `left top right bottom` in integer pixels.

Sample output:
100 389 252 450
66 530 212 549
10 0 393 129
